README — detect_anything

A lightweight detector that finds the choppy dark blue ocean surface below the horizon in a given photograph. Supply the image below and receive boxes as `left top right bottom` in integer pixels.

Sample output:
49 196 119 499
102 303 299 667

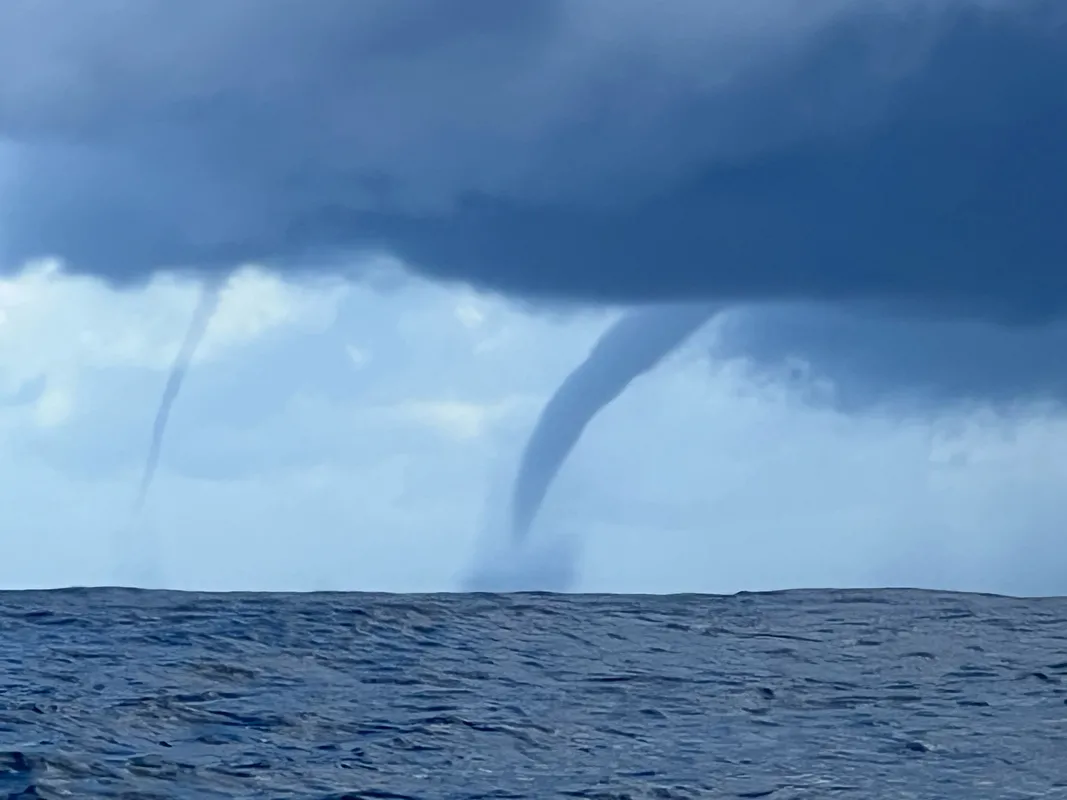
0 590 1067 800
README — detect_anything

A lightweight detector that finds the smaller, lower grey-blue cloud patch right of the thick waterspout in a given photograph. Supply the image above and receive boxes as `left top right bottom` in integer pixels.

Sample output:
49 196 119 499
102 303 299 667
712 305 1067 414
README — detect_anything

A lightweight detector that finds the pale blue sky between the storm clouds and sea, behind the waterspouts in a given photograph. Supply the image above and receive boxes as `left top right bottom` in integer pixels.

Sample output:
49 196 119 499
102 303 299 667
0 265 1067 593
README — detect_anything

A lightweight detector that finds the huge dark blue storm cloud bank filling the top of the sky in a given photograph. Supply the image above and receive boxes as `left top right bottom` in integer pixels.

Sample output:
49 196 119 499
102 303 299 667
0 0 1067 322
